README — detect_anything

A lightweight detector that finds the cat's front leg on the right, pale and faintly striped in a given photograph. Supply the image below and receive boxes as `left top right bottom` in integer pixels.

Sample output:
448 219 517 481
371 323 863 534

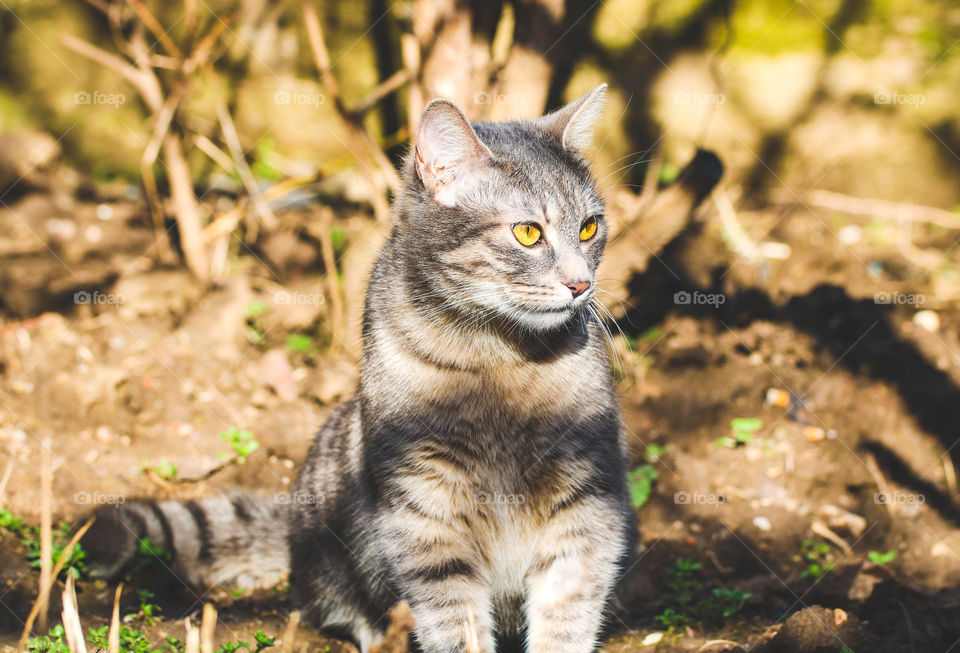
526 502 626 653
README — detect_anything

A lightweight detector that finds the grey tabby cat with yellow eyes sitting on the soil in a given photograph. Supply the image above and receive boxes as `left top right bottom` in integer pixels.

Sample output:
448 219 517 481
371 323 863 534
86 86 635 653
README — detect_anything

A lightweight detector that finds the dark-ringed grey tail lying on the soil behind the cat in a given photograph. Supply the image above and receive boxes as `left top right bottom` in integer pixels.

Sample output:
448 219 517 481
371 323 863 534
81 493 290 588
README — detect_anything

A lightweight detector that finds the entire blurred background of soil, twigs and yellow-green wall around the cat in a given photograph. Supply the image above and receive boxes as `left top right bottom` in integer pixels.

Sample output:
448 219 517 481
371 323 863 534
0 0 960 652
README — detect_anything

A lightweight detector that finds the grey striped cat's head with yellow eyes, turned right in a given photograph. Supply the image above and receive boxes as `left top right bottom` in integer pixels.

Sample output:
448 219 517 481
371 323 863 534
398 85 607 331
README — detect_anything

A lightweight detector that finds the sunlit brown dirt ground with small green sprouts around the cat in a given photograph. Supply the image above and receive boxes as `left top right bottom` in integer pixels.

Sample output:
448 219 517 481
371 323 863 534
0 181 960 653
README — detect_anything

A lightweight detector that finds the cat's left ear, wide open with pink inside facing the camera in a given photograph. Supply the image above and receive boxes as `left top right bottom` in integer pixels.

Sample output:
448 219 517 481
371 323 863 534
413 99 493 206
